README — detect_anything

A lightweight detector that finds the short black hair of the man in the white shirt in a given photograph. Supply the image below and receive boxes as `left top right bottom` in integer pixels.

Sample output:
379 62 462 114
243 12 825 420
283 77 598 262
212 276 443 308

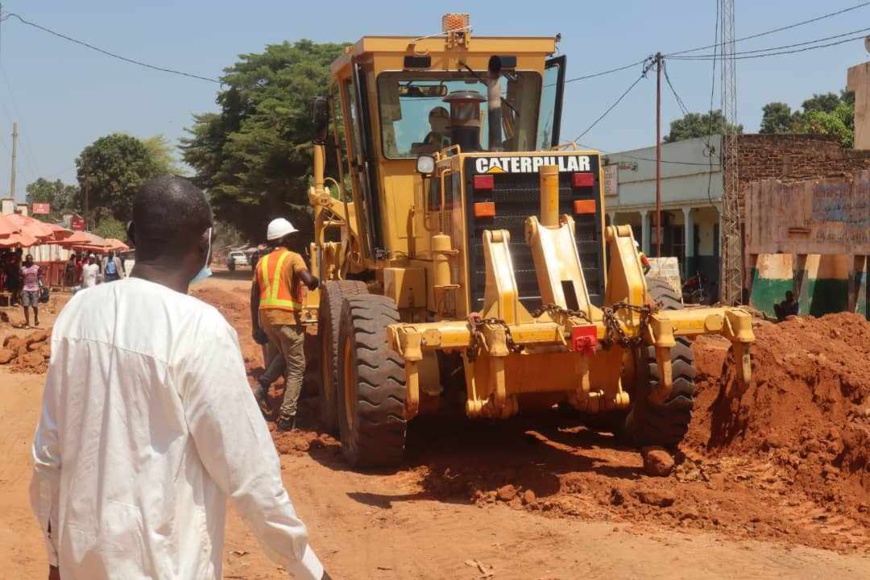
133 177 212 260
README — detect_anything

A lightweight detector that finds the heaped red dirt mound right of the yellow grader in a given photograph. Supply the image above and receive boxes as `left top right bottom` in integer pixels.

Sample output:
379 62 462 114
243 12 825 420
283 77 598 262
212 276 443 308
688 313 870 523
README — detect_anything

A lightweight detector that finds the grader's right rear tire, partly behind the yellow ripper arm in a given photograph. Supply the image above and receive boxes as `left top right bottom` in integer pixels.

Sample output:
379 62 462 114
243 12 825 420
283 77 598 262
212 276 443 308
623 279 695 448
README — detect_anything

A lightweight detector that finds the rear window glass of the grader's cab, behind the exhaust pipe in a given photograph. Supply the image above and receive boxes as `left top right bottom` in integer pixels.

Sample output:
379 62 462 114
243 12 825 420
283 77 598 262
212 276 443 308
378 72 550 159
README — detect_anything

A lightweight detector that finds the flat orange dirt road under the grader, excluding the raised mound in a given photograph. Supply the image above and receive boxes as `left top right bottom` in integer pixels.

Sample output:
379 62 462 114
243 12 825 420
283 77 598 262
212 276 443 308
0 275 870 580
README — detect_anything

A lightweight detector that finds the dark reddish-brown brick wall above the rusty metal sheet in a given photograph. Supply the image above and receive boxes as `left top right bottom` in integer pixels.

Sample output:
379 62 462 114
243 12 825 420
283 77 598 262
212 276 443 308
738 134 870 184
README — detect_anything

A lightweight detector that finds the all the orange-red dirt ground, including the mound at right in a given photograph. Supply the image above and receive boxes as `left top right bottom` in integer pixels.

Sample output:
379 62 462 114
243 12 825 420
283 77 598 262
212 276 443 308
0 272 870 580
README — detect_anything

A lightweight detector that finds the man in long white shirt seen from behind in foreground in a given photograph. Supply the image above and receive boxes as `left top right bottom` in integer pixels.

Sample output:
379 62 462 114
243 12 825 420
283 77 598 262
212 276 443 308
30 177 329 580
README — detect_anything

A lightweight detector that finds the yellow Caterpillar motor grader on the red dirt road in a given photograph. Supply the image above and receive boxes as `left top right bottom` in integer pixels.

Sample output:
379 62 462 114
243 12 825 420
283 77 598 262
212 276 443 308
305 14 754 467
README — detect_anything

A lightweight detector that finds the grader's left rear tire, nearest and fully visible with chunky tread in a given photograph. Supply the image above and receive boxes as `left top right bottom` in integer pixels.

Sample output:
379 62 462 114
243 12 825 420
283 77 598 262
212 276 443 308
338 295 407 467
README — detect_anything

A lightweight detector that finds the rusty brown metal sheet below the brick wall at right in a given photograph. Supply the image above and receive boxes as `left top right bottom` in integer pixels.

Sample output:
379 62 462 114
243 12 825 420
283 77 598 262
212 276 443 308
744 171 870 256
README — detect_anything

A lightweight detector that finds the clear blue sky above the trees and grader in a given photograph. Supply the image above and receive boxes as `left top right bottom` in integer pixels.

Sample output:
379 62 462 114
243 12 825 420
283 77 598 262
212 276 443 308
0 0 870 196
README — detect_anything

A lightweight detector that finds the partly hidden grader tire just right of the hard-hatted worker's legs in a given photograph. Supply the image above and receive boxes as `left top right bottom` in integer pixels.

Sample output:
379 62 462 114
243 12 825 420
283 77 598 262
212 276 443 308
317 280 367 435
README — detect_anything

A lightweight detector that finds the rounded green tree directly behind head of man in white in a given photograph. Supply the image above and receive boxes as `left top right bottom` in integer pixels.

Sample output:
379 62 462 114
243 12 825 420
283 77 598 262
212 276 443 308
76 133 161 221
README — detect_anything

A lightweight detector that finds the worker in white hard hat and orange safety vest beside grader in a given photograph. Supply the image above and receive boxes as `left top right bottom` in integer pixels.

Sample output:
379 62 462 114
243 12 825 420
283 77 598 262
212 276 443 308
251 218 320 431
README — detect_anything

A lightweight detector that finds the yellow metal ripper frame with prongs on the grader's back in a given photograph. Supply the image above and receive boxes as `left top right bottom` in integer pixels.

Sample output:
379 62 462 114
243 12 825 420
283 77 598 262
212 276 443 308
387 168 754 418
